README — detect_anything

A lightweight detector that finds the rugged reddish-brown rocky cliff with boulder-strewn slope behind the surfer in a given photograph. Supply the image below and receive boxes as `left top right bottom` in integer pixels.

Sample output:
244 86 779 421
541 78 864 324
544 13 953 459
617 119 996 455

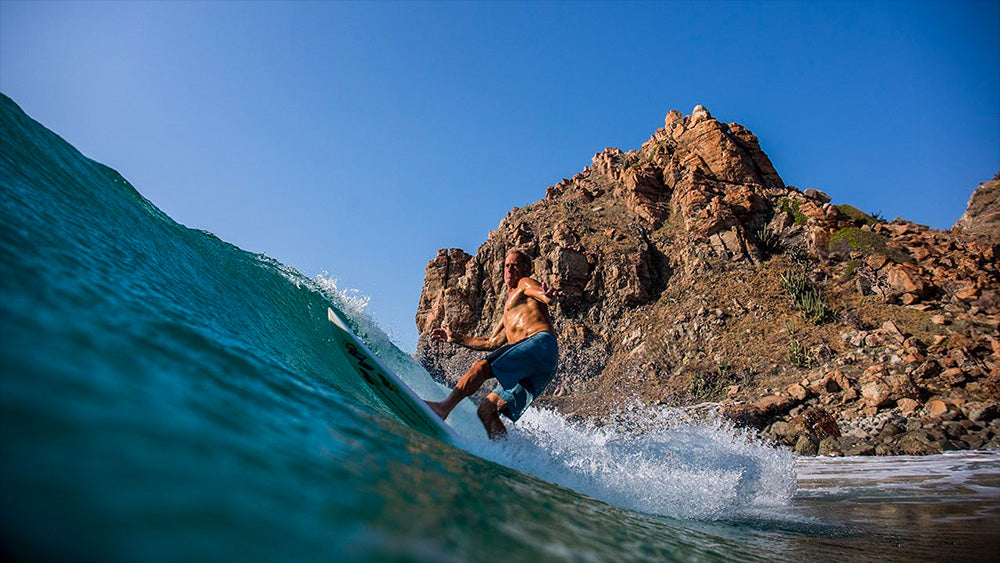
416 106 1000 454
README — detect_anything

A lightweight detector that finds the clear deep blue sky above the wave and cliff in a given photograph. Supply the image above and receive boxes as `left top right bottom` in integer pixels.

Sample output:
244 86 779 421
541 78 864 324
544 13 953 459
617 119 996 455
0 1 1000 351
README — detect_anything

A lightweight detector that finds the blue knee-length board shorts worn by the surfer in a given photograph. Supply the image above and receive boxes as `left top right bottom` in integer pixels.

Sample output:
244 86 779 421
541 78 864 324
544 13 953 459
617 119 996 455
486 332 559 421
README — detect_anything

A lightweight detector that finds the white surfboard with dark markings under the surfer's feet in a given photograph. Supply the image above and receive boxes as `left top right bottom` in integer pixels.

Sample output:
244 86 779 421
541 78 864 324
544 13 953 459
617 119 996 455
326 308 456 443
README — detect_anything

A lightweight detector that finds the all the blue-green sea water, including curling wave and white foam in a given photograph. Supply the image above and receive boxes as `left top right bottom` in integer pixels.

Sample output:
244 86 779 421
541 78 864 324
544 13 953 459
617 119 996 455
0 96 1000 561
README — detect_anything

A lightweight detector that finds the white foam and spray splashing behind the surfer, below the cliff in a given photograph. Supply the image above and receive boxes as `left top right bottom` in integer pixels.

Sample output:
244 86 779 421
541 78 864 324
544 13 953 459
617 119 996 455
467 408 795 520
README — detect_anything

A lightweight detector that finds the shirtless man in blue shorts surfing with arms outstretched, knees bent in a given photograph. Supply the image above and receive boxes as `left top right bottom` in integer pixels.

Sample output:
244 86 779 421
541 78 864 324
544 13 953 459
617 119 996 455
427 251 562 439
